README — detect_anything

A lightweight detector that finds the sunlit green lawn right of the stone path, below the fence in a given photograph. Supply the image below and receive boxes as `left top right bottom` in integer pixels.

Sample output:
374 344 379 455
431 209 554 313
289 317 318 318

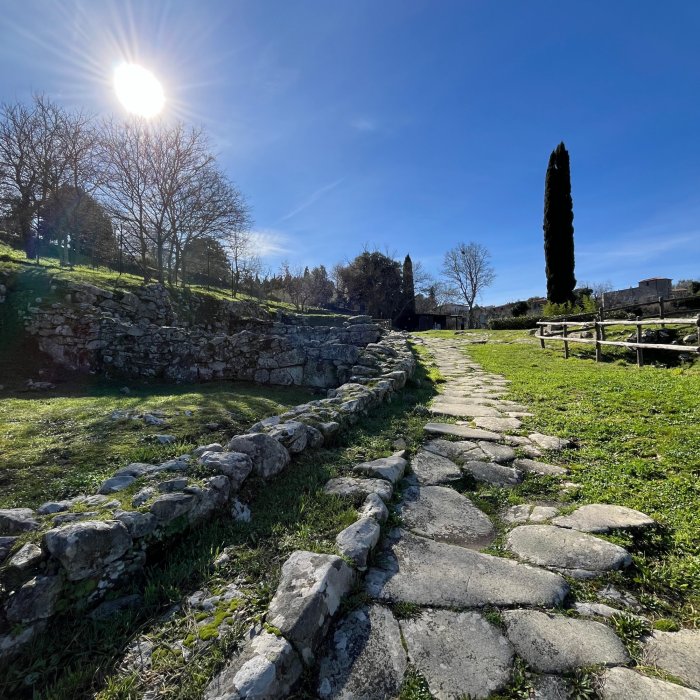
424 331 700 626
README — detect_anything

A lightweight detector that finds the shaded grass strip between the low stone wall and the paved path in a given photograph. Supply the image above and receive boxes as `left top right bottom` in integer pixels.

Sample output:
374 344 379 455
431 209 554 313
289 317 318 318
0 348 435 700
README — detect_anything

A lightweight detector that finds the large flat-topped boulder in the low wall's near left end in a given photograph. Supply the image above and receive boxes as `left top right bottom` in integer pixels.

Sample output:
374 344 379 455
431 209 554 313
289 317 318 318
43 520 133 581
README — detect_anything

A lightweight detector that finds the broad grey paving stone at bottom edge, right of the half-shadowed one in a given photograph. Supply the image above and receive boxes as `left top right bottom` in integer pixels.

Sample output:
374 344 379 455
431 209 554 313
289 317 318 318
400 610 514 700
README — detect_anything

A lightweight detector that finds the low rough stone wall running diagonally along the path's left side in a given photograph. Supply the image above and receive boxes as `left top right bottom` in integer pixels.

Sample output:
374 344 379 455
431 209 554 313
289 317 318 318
0 333 415 661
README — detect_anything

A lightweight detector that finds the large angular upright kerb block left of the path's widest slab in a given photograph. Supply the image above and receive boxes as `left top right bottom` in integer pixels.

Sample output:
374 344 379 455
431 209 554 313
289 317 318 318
267 551 355 664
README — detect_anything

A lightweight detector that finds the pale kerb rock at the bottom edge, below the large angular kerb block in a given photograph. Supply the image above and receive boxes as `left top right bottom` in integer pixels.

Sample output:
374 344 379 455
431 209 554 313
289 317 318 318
204 628 303 700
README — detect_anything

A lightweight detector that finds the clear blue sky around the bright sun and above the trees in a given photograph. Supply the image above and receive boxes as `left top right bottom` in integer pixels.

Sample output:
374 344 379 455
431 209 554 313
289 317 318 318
0 0 700 303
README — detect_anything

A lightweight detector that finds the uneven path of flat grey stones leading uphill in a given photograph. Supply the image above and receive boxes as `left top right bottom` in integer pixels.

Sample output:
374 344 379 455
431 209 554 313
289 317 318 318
317 338 700 700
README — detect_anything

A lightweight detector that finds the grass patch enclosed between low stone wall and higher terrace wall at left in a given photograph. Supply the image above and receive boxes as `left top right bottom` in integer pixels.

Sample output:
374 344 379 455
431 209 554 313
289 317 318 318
0 377 313 508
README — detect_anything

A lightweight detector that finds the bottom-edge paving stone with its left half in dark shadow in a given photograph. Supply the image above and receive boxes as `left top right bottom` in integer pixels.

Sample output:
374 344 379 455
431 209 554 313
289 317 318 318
318 605 407 700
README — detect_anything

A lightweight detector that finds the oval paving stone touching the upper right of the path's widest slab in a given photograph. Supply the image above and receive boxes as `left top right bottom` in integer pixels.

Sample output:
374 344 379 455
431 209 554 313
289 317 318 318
506 525 632 578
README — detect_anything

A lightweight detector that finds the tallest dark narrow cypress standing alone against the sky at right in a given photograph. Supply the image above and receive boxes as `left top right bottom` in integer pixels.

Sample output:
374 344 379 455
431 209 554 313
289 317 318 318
543 142 576 304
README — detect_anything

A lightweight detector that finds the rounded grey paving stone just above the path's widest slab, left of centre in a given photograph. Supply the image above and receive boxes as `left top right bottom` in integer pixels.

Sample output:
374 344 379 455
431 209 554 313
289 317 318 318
398 486 496 549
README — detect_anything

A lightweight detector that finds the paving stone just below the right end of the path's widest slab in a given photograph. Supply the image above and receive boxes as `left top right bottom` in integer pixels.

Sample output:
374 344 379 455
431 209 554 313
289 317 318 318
502 610 631 673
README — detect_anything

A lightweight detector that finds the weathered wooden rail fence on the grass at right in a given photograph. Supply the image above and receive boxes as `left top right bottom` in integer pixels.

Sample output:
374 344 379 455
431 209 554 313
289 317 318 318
537 316 700 367
